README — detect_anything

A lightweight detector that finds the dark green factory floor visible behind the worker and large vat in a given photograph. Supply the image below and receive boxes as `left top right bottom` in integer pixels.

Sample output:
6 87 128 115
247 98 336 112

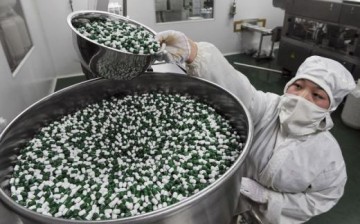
55 55 360 224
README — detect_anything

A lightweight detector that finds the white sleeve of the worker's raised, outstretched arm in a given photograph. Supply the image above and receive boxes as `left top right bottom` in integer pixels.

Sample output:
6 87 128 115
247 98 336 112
187 42 267 123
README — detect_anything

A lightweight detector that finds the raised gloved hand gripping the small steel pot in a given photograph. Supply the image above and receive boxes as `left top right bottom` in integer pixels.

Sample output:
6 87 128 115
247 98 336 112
156 30 192 64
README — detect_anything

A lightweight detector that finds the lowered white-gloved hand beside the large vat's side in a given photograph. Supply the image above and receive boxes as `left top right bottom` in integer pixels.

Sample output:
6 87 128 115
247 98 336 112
240 177 268 203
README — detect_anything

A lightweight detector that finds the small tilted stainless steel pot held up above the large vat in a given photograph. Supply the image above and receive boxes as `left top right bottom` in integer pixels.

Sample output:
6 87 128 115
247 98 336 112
67 10 161 80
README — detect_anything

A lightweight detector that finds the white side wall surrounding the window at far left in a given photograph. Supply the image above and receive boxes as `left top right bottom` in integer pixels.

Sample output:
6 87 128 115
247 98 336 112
0 0 55 121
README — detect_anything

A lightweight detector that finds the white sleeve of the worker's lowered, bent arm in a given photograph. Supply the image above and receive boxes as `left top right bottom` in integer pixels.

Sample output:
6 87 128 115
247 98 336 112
259 166 347 224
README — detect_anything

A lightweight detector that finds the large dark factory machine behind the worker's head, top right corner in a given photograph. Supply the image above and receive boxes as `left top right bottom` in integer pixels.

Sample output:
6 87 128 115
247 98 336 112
273 0 360 80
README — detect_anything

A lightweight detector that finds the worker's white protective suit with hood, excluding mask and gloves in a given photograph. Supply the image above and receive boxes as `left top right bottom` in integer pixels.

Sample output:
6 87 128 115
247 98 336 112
187 42 355 224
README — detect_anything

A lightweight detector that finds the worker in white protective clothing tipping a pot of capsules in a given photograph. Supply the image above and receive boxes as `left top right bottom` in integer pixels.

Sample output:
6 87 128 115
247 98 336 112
157 30 355 224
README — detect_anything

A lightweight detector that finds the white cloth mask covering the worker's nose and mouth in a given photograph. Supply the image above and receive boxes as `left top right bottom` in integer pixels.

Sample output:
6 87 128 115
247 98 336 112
279 94 333 136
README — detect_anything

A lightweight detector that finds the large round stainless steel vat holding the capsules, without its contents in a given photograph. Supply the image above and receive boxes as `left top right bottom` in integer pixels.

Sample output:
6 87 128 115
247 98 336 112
0 73 253 224
